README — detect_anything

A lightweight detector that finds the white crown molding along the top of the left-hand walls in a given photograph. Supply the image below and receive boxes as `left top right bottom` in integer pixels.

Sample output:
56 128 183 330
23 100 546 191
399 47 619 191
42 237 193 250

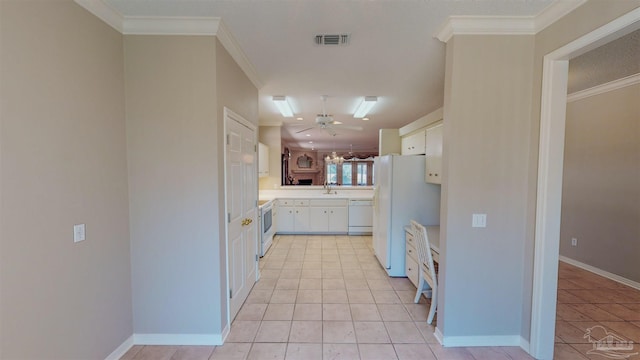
75 0 263 89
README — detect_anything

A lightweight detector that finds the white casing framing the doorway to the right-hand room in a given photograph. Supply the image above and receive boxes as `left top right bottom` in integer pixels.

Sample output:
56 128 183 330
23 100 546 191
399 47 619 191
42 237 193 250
529 8 640 359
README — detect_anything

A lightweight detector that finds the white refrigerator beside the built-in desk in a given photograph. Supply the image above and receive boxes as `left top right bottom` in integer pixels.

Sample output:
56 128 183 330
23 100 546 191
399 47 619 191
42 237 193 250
373 155 440 276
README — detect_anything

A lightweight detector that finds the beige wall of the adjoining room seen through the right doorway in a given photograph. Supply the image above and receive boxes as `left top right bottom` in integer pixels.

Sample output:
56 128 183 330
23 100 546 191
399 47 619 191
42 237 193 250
560 85 640 282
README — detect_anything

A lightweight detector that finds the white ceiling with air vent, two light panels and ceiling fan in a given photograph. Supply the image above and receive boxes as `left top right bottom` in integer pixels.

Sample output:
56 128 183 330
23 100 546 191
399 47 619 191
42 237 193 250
104 0 553 150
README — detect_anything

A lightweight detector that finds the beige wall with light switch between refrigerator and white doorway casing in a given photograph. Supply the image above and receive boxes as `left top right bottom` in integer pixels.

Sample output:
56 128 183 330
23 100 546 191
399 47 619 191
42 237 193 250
438 0 640 341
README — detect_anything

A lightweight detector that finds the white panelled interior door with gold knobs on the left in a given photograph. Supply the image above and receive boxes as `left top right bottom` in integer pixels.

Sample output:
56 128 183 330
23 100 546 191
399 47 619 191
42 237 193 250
225 109 258 320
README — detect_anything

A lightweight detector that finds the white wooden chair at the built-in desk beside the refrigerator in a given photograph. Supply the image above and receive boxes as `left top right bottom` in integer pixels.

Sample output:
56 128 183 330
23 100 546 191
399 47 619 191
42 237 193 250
411 220 438 324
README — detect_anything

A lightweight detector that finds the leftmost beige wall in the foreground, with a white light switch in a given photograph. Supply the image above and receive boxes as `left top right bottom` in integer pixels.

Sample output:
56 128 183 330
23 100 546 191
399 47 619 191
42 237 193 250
0 0 132 359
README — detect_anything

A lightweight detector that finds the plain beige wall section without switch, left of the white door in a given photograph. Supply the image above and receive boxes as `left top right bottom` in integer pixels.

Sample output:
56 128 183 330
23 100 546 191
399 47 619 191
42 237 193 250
125 36 224 335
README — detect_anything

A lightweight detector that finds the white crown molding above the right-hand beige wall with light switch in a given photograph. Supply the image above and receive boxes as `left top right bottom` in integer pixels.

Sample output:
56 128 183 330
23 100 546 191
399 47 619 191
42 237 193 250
436 0 587 43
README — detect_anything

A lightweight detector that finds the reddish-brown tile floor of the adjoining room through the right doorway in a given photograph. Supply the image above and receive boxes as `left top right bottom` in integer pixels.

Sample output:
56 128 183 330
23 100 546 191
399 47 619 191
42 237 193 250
554 262 640 360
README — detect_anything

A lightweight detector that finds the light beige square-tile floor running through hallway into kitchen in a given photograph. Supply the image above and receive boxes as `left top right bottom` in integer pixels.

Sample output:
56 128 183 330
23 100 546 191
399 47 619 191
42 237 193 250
123 235 531 360
